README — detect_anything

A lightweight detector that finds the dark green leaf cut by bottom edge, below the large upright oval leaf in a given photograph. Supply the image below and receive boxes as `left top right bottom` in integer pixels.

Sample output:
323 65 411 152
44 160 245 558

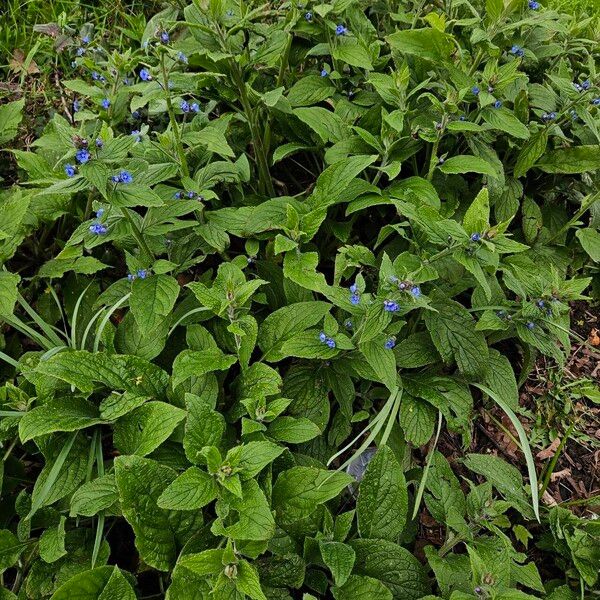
350 539 429 600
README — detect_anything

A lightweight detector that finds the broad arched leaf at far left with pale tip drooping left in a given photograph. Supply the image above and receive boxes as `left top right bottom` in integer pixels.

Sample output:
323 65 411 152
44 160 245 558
19 396 102 443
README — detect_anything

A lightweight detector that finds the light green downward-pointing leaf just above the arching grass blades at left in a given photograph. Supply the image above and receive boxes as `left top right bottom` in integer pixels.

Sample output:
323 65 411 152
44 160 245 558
129 275 179 332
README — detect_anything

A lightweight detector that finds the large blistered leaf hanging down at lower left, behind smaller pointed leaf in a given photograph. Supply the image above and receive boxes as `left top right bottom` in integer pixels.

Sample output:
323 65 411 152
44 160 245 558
115 456 177 571
